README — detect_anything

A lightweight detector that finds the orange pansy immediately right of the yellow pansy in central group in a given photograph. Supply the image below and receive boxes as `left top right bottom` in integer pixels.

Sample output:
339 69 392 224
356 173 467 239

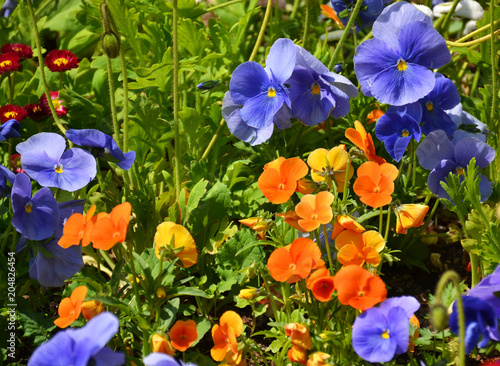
353 161 398 208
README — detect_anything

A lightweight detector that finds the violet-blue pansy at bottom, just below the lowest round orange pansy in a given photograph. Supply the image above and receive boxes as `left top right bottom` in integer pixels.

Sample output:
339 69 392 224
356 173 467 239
352 296 420 362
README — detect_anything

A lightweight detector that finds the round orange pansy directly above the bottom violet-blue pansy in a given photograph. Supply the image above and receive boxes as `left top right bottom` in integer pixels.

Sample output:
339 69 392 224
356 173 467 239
334 266 387 310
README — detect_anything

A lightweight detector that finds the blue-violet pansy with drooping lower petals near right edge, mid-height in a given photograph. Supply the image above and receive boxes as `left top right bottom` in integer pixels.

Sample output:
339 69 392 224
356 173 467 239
417 130 495 201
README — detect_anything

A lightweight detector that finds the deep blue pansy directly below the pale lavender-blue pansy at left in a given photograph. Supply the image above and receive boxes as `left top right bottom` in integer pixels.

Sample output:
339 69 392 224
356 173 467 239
11 173 59 240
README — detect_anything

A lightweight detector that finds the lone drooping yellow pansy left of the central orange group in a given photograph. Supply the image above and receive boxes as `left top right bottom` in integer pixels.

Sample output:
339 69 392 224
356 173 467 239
154 221 198 268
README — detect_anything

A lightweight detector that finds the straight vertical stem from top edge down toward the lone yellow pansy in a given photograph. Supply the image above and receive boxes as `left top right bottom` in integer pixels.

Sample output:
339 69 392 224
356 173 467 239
172 0 181 199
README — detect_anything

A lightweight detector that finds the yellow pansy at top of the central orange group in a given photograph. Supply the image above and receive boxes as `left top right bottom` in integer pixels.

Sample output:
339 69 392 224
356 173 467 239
307 145 354 187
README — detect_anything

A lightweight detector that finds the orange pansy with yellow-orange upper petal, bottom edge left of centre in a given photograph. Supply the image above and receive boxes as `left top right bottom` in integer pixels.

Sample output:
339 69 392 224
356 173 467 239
210 310 246 366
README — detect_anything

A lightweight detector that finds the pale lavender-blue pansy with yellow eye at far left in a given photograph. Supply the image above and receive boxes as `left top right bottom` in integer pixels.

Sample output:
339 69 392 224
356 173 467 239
16 132 97 192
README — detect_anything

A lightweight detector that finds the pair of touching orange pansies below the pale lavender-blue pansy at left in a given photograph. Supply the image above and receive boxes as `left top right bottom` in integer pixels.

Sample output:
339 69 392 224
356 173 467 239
58 202 132 250
